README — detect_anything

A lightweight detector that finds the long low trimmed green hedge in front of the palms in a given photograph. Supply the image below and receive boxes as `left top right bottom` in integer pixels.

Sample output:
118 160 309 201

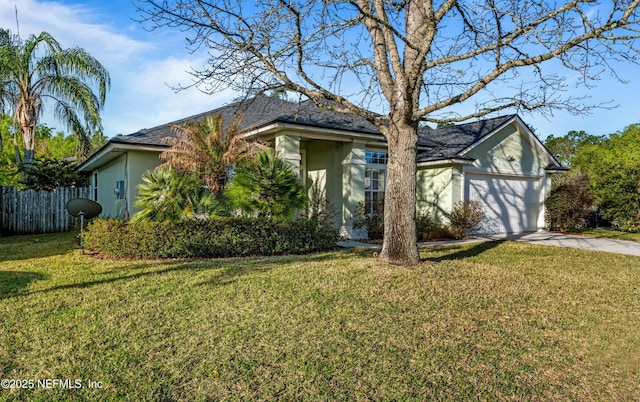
84 218 339 259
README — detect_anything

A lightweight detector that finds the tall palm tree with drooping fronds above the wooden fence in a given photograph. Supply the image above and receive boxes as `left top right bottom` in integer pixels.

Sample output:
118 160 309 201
0 29 110 165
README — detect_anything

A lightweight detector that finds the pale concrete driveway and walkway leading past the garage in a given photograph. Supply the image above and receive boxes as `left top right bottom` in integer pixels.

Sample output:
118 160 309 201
339 232 640 256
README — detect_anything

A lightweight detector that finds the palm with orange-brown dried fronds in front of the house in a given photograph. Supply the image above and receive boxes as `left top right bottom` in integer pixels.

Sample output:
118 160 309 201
160 115 266 194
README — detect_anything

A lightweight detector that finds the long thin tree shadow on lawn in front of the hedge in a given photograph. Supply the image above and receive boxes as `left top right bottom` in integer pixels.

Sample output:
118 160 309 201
23 253 338 294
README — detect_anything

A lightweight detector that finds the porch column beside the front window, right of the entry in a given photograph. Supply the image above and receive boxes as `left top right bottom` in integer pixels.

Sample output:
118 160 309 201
340 142 367 239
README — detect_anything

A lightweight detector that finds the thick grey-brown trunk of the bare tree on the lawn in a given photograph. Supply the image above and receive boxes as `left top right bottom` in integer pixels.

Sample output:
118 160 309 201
380 115 420 265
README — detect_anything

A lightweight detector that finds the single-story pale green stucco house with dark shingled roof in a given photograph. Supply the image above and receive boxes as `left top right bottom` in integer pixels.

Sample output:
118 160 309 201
79 97 564 238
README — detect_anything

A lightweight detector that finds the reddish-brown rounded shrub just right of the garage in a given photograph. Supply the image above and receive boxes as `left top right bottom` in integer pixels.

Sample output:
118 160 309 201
545 173 593 231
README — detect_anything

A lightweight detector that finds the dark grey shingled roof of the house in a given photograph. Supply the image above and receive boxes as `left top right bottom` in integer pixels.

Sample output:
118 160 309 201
111 96 516 162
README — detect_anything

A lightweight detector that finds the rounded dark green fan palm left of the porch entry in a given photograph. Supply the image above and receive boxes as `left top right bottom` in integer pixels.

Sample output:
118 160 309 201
226 152 307 219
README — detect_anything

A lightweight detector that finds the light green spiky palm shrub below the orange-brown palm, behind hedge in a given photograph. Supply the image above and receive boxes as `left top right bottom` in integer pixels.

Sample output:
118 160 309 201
132 167 226 223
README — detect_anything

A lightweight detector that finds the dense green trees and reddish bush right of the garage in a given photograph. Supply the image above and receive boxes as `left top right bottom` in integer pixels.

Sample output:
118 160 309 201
545 124 640 231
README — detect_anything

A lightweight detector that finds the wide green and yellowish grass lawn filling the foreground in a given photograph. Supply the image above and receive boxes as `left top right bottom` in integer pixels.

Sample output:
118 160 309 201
0 235 640 401
